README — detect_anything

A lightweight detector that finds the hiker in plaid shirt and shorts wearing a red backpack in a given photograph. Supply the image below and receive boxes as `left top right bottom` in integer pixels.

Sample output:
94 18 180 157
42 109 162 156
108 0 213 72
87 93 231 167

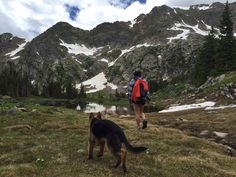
128 70 150 129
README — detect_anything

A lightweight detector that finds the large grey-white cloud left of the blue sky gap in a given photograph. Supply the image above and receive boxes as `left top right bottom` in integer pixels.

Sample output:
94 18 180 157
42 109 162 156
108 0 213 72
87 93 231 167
0 0 74 39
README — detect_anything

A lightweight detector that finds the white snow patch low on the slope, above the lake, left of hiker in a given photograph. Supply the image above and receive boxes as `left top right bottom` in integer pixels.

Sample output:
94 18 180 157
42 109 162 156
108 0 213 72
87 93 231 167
76 72 118 93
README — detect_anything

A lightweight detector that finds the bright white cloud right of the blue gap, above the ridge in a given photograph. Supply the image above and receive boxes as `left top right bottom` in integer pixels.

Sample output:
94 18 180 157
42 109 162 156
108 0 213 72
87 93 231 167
76 0 166 29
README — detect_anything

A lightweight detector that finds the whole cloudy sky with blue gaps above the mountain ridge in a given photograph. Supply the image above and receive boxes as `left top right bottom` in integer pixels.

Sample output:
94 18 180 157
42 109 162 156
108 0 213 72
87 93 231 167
0 0 236 40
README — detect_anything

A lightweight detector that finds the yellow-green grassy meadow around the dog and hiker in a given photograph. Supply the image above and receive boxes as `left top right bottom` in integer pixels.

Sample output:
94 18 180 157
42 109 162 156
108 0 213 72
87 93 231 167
0 99 236 177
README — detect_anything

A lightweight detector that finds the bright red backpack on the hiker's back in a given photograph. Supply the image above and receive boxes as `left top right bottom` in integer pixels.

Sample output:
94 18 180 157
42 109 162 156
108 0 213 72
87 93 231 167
131 79 148 102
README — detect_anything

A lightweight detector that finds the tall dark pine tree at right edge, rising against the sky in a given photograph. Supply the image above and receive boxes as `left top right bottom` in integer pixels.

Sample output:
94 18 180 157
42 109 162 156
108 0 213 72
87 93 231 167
215 1 236 74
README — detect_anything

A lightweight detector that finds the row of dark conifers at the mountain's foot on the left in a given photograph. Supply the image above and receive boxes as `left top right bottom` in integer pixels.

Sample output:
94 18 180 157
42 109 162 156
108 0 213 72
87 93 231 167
0 61 86 99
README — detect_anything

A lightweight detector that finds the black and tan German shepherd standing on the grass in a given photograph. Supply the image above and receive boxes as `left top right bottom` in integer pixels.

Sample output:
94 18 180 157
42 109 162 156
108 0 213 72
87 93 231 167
88 112 147 172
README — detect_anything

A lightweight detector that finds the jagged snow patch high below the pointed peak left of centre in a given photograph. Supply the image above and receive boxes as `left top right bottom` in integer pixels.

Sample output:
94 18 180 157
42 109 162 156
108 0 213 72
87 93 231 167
60 39 98 55
